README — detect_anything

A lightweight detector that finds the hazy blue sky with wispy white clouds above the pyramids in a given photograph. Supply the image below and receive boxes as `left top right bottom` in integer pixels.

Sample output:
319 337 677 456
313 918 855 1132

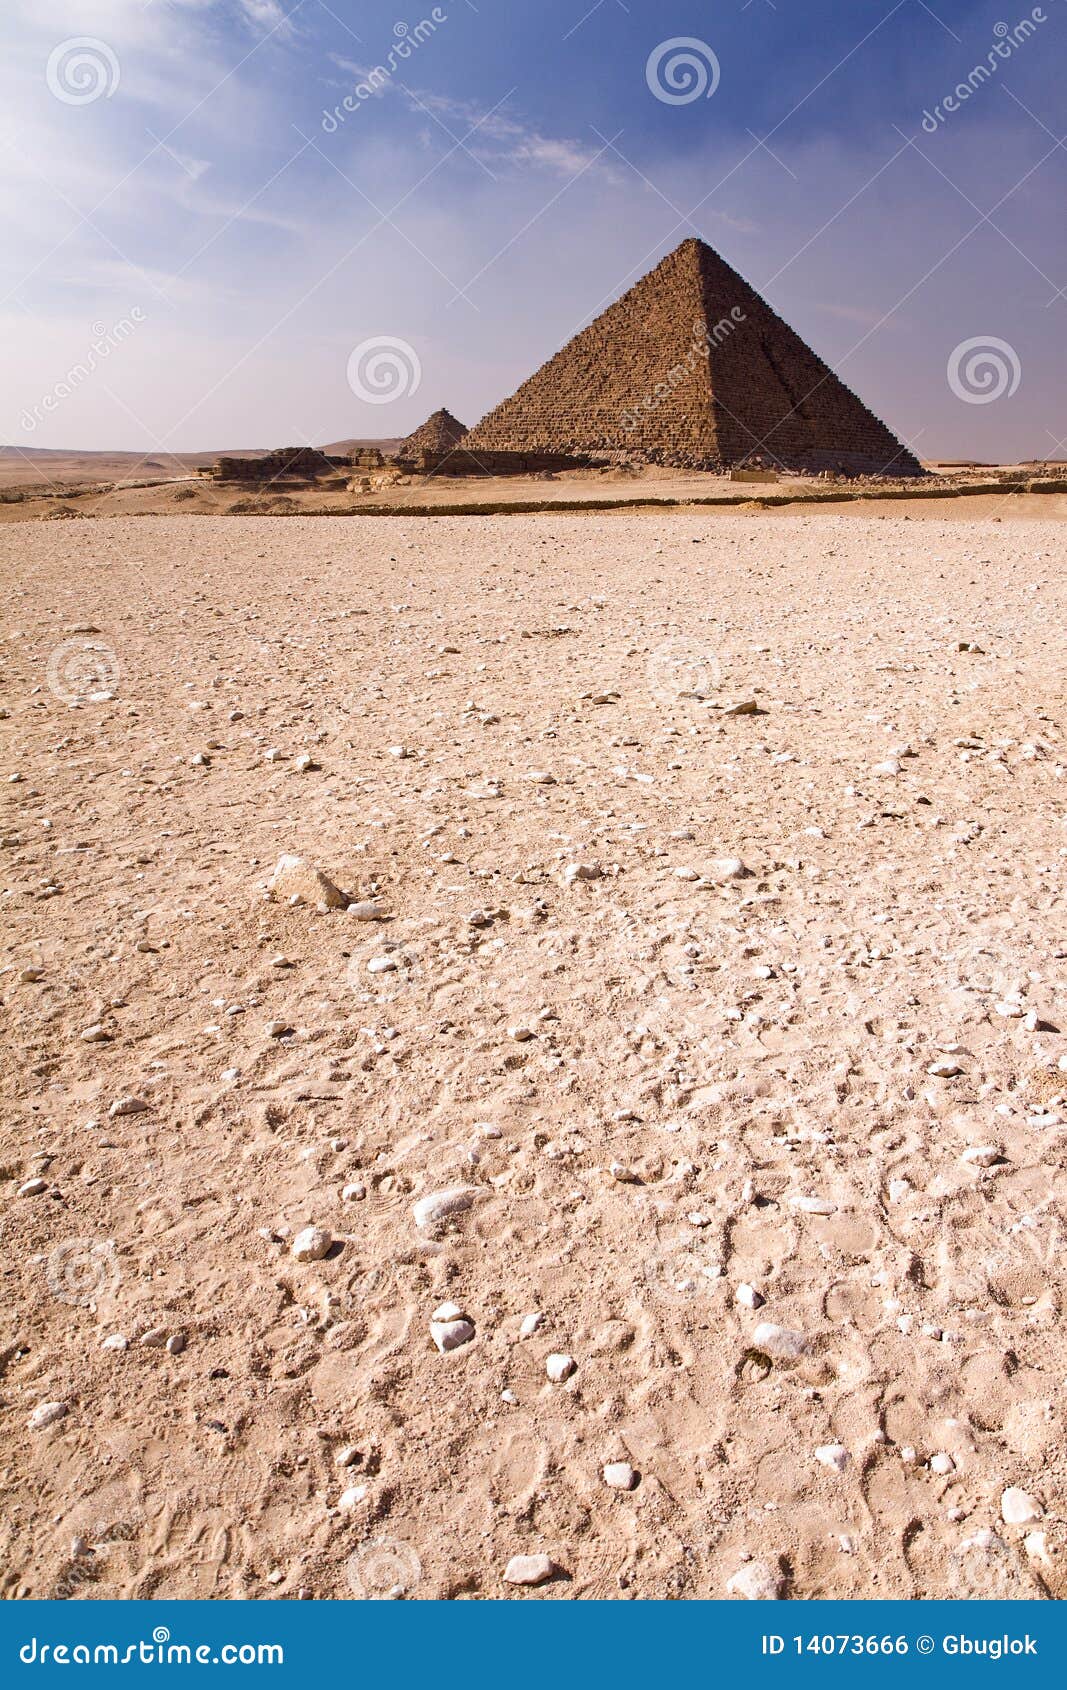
0 0 1067 458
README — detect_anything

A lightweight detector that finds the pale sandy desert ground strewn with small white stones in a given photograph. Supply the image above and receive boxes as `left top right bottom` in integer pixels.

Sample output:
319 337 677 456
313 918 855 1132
0 510 1067 1600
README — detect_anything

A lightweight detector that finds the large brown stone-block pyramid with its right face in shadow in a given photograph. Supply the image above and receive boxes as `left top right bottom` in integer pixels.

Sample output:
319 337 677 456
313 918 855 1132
463 240 922 475
